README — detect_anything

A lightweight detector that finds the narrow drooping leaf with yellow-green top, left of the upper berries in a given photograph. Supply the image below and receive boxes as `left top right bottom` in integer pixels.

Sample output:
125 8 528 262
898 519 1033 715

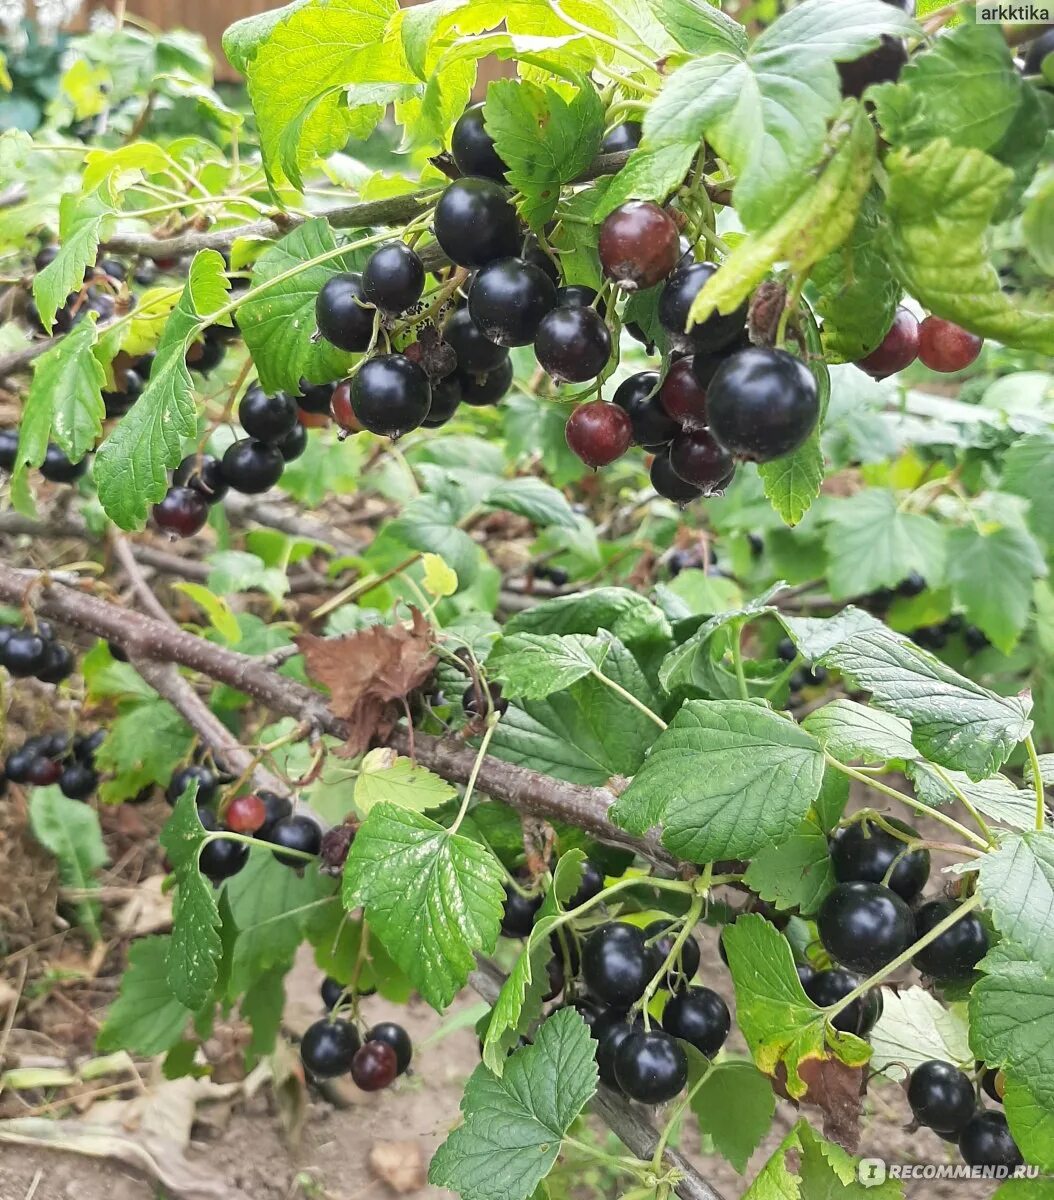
94 250 228 529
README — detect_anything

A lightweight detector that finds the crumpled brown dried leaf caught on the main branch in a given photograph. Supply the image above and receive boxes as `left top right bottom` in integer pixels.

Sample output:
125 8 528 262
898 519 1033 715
297 608 437 756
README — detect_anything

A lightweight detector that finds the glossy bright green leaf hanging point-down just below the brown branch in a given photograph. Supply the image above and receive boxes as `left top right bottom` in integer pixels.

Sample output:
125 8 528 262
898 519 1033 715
343 804 505 1010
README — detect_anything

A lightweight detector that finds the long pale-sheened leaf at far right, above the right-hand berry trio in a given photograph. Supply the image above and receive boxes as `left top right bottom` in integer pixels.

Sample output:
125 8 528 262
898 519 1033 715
822 629 1032 780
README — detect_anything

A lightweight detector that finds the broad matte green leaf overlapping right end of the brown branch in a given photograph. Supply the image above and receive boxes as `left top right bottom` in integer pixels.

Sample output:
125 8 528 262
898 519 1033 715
611 700 824 863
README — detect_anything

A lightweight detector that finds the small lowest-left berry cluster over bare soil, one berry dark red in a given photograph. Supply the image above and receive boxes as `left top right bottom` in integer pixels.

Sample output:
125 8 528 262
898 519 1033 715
300 978 413 1092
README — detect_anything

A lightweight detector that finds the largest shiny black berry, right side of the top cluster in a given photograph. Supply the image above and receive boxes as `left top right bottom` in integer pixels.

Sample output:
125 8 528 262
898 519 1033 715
706 347 820 462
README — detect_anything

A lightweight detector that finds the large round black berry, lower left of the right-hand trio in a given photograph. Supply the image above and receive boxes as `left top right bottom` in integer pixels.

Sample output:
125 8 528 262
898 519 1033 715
816 883 915 974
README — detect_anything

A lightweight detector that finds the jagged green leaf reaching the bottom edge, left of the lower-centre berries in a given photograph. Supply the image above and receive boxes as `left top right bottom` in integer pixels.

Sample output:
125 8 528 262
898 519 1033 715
429 1008 597 1200
